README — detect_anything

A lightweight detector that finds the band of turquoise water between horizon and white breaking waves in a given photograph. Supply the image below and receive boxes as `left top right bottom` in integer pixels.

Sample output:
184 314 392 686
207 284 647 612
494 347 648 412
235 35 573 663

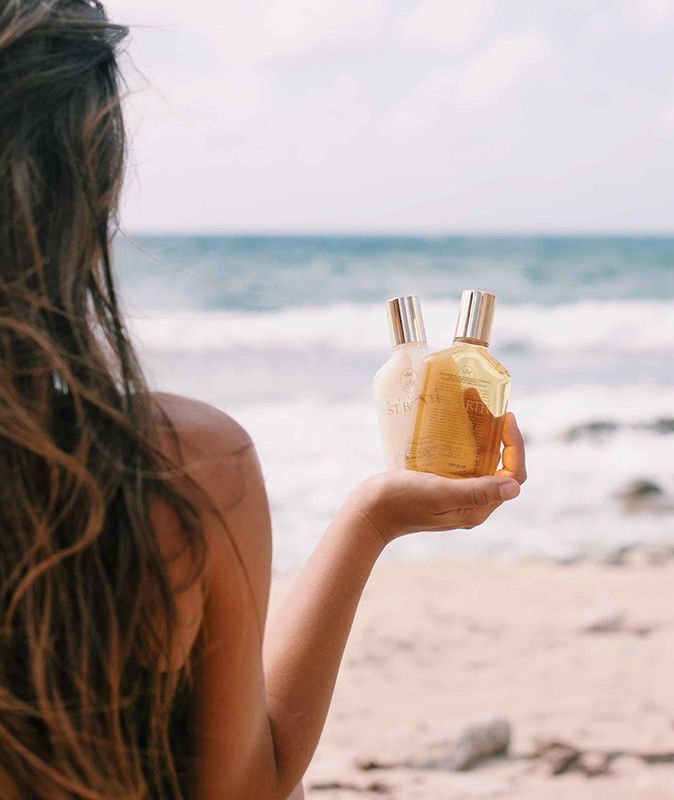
118 237 674 310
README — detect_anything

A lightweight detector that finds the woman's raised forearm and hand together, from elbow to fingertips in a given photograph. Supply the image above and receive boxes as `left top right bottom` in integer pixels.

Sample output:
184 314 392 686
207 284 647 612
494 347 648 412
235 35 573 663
264 416 526 786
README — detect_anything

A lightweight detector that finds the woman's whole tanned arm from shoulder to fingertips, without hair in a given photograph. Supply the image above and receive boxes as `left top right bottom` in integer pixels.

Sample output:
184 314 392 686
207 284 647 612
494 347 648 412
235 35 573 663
159 396 523 800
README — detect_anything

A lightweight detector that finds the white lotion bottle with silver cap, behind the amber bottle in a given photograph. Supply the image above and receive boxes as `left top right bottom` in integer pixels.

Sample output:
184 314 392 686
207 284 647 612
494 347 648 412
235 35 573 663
372 296 428 469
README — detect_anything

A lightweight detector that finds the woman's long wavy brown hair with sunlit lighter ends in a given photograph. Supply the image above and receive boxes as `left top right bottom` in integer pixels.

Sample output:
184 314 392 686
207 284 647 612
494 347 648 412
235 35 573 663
0 0 204 800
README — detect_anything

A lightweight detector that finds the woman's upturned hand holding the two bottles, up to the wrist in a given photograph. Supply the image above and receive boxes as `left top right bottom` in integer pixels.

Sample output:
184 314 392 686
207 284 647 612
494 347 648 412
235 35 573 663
347 414 527 544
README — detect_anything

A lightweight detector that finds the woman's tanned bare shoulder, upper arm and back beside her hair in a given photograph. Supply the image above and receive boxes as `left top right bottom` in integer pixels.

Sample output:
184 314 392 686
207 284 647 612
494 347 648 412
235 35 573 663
152 394 302 800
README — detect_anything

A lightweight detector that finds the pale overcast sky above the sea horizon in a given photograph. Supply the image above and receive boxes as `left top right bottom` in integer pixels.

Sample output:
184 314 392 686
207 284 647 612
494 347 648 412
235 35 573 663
107 0 674 232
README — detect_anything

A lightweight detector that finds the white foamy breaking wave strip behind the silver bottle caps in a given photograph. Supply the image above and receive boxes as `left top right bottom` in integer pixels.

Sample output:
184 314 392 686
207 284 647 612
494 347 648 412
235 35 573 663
130 300 674 354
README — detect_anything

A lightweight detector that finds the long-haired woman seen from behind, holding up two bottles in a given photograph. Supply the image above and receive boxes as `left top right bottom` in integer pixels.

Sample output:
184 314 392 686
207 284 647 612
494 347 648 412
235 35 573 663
0 0 525 800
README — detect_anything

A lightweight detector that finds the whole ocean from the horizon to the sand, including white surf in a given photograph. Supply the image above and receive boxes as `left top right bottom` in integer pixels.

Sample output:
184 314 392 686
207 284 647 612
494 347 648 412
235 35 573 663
116 236 674 570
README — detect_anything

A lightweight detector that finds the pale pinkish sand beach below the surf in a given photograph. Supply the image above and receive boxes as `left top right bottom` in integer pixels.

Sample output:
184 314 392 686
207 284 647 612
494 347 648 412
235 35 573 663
272 561 674 800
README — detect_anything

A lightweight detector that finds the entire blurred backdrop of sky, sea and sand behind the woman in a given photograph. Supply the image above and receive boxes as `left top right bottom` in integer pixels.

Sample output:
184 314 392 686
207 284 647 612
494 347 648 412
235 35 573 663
103 0 674 800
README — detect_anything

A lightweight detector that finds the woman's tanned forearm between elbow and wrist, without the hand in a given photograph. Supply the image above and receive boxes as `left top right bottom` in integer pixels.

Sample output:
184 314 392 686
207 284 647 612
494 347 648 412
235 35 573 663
264 506 384 787
